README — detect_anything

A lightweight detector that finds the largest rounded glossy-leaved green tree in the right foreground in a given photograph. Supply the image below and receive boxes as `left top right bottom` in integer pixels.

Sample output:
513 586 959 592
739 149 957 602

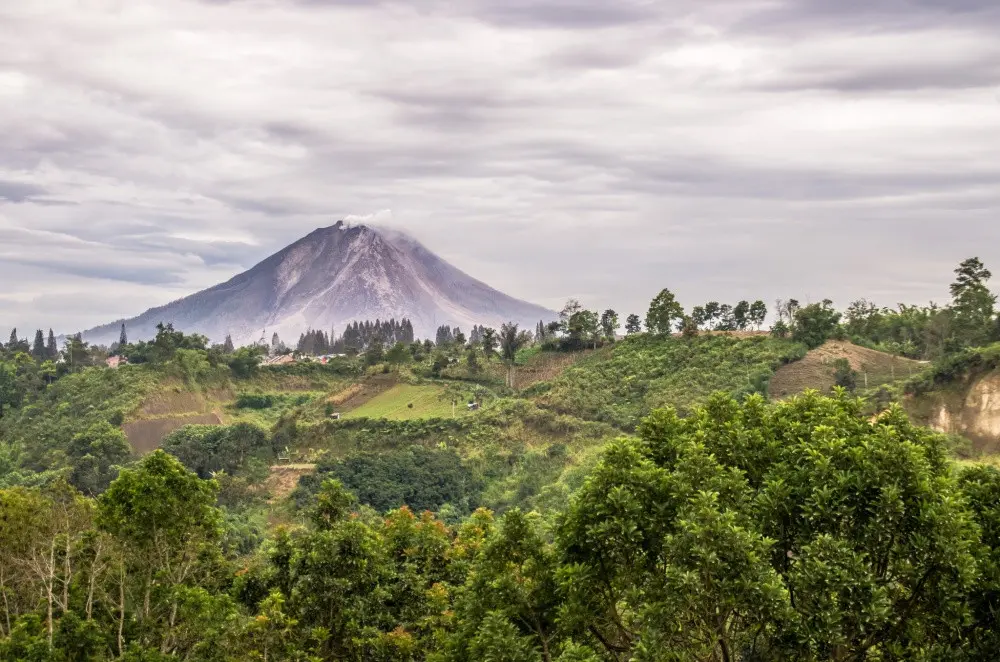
557 393 976 660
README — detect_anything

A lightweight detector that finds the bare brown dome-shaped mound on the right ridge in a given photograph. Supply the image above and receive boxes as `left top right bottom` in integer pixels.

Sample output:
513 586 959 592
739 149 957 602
768 340 928 399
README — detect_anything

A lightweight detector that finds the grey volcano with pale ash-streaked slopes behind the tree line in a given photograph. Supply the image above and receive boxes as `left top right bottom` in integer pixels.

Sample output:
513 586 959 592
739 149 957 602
83 222 558 345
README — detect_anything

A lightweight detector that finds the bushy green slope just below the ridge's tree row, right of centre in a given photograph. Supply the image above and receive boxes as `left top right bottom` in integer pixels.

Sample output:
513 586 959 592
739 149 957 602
525 334 805 430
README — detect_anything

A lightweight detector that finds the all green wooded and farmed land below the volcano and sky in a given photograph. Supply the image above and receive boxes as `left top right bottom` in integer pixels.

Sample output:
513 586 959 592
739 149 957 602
0 259 1000 662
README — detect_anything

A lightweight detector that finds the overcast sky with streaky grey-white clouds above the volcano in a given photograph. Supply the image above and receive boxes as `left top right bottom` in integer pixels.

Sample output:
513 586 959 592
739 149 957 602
0 0 1000 335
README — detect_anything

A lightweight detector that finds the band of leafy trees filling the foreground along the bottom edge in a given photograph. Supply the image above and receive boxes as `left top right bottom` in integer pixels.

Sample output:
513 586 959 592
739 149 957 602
0 393 1000 662
